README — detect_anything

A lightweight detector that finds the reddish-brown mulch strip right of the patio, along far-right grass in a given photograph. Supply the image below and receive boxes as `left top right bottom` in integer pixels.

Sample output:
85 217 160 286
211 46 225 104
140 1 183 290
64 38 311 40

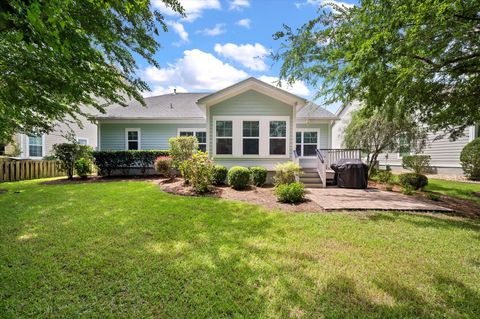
368 181 480 218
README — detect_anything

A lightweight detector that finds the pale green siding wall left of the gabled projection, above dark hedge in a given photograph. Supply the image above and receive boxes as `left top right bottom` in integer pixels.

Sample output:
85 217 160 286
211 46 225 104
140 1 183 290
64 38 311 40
99 123 206 151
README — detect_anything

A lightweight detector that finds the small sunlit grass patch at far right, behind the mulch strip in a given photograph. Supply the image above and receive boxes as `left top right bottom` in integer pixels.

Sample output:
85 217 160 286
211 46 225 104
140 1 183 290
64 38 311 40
425 179 480 204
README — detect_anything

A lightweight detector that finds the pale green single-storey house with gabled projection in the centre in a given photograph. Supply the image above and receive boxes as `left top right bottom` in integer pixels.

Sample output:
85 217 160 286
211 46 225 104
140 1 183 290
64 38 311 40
96 78 337 186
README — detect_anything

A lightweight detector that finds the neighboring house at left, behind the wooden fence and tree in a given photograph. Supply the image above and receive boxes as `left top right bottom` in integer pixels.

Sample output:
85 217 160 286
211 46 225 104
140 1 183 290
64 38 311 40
7 115 97 159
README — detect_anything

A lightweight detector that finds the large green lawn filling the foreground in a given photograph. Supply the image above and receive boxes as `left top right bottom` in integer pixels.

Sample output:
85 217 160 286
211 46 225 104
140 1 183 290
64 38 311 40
0 181 480 318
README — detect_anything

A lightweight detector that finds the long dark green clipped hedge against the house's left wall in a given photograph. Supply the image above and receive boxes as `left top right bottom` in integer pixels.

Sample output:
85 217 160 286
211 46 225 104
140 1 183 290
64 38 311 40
92 151 168 176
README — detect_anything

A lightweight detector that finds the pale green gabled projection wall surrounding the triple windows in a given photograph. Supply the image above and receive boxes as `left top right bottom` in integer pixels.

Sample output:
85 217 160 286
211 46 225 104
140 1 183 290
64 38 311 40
207 90 295 169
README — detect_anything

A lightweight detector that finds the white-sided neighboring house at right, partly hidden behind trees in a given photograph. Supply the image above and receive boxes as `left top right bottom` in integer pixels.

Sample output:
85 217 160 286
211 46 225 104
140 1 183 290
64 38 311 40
332 102 480 175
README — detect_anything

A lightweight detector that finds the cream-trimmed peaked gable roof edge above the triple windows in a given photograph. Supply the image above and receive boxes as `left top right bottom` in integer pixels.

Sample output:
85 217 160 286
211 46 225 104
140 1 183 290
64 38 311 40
198 77 308 105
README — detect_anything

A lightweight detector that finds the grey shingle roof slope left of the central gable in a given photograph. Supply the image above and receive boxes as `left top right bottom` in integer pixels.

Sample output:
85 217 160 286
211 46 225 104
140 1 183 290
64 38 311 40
97 93 209 119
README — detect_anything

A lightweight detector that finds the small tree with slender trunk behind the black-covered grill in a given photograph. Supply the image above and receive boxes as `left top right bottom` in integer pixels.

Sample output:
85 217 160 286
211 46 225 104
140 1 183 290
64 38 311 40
344 109 427 176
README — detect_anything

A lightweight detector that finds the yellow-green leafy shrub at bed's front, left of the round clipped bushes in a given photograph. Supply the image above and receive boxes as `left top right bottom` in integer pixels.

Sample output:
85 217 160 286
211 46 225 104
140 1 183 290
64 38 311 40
186 151 215 193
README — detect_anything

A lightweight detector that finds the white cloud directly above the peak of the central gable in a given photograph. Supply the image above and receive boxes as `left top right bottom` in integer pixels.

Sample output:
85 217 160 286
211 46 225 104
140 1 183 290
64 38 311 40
215 43 269 71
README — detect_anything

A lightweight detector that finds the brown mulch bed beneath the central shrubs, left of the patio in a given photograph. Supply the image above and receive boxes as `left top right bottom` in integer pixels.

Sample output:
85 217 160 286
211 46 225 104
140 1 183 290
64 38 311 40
159 178 323 212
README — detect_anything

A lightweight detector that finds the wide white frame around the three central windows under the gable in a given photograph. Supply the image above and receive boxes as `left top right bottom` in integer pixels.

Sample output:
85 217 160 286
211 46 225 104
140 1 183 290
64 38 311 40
211 115 292 159
